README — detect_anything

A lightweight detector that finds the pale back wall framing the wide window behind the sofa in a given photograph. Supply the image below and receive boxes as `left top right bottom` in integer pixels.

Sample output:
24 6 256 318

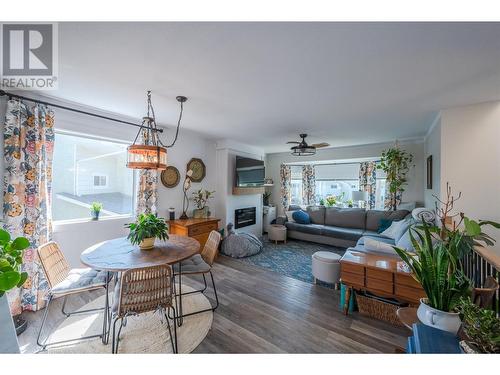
266 141 424 214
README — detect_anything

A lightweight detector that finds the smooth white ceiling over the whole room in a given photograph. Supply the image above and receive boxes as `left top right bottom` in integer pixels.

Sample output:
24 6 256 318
51 23 500 152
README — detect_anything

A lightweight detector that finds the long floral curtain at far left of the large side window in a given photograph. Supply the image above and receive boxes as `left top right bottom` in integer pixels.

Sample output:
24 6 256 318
3 100 54 315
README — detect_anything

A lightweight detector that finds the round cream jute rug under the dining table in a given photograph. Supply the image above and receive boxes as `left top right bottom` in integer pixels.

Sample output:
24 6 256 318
47 285 213 354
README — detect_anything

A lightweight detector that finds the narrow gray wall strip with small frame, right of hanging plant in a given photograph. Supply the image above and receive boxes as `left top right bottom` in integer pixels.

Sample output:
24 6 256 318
422 116 441 208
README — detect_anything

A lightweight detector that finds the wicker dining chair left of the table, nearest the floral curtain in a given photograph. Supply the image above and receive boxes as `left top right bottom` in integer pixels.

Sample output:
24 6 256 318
37 242 109 349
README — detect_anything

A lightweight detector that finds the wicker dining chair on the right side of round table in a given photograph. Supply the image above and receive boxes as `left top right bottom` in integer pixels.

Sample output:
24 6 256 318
174 230 221 319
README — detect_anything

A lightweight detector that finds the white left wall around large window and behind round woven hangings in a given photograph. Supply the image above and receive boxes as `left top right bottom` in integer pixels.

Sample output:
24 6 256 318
0 93 217 267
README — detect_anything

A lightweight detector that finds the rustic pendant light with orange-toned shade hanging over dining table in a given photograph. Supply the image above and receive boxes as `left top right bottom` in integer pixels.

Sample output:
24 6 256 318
127 91 187 170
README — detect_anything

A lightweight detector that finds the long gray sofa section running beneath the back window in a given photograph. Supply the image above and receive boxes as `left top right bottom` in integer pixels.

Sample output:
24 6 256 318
285 206 410 247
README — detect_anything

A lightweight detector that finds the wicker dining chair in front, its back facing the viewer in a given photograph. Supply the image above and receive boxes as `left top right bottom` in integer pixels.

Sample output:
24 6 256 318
111 265 177 353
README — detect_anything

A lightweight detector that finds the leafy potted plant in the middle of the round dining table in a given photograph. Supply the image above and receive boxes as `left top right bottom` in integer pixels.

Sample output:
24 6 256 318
125 214 168 250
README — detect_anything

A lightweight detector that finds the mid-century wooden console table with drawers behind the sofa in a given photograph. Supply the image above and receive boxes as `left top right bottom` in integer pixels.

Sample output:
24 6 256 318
340 250 425 314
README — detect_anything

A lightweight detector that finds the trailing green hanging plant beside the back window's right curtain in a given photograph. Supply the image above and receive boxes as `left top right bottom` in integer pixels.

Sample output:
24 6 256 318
377 142 413 210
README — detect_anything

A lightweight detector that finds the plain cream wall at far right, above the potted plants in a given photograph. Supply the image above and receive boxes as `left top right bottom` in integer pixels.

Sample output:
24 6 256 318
441 102 500 254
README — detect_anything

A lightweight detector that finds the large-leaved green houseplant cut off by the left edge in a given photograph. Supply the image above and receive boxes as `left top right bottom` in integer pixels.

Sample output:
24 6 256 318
0 229 30 297
